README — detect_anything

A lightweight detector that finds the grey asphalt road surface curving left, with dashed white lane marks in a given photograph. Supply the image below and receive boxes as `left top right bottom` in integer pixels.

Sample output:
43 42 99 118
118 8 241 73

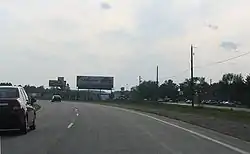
1 101 250 154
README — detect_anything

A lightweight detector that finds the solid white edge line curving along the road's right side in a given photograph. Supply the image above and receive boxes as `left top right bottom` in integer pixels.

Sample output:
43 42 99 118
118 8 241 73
105 106 250 154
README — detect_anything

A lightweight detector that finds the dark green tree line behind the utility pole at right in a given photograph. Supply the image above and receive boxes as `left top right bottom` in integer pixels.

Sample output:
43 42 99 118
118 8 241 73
131 73 250 106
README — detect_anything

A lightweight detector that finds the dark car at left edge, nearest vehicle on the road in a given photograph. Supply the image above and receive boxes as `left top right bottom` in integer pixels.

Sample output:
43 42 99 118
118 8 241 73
0 86 36 134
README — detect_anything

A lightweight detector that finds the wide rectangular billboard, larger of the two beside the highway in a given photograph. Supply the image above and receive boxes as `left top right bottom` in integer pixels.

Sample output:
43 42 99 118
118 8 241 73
76 76 114 90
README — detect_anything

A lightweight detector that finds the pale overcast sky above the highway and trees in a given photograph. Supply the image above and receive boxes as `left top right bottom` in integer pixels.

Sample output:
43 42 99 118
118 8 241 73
0 0 250 88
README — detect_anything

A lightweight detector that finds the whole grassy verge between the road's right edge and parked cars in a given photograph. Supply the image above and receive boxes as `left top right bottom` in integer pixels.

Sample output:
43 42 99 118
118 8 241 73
93 102 250 141
